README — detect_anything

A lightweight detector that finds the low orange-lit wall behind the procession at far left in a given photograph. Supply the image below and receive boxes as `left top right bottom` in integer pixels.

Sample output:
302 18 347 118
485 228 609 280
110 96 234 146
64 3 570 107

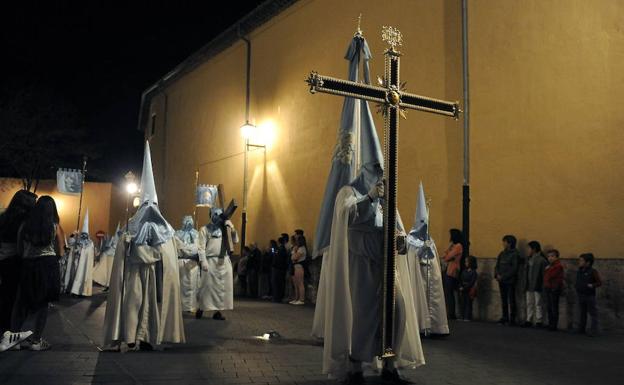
0 178 117 239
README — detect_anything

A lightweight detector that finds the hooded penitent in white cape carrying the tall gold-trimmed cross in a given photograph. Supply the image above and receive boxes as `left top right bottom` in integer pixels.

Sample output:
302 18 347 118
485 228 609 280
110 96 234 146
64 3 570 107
312 34 424 377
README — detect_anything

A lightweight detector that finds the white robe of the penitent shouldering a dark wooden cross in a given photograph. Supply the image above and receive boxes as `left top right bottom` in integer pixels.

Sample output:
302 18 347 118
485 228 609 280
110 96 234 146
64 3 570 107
197 226 238 310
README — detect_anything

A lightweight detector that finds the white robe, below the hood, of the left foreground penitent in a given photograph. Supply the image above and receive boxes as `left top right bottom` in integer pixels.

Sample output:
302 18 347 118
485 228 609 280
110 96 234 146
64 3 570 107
104 234 186 346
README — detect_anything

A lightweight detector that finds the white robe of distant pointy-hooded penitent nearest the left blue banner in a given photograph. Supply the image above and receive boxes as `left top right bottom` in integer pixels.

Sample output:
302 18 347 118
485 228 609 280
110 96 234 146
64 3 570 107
63 241 95 297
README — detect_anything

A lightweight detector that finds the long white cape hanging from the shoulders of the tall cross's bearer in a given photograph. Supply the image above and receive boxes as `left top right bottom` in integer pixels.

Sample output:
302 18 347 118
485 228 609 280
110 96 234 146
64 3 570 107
312 186 425 377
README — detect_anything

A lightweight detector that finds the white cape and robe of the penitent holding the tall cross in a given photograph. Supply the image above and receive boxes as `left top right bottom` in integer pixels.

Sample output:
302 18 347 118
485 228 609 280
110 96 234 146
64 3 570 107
312 186 425 377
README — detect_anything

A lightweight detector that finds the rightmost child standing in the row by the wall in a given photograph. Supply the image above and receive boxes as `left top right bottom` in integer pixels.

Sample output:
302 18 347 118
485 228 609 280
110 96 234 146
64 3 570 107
576 253 602 337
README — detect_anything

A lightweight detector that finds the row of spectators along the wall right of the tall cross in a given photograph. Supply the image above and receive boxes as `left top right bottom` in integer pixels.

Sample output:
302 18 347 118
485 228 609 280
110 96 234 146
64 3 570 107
441 229 602 336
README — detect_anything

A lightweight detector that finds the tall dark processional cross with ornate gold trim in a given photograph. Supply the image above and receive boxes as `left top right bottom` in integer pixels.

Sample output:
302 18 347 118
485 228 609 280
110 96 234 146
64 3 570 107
306 26 461 358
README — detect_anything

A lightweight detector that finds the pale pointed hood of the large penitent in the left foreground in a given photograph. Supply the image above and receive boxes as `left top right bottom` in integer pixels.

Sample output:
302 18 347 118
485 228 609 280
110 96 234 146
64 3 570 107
128 141 175 247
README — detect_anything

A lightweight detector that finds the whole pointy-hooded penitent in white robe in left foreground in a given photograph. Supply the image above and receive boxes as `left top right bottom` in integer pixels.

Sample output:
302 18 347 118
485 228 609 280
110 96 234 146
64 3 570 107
104 142 185 346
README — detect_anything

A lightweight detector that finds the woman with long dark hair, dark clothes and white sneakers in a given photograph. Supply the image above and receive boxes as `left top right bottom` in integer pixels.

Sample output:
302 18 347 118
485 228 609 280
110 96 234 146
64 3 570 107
12 195 64 350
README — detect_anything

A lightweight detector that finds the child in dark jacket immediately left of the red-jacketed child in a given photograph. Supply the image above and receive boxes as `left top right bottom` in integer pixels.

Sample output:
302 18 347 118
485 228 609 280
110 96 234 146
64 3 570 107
522 241 548 327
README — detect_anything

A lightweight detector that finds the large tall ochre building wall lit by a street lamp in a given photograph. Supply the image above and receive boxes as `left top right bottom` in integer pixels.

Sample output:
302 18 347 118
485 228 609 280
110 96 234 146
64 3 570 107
151 0 624 258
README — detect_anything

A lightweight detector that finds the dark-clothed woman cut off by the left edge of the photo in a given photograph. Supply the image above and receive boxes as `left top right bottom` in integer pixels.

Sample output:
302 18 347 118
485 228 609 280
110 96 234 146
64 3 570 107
0 190 37 335
